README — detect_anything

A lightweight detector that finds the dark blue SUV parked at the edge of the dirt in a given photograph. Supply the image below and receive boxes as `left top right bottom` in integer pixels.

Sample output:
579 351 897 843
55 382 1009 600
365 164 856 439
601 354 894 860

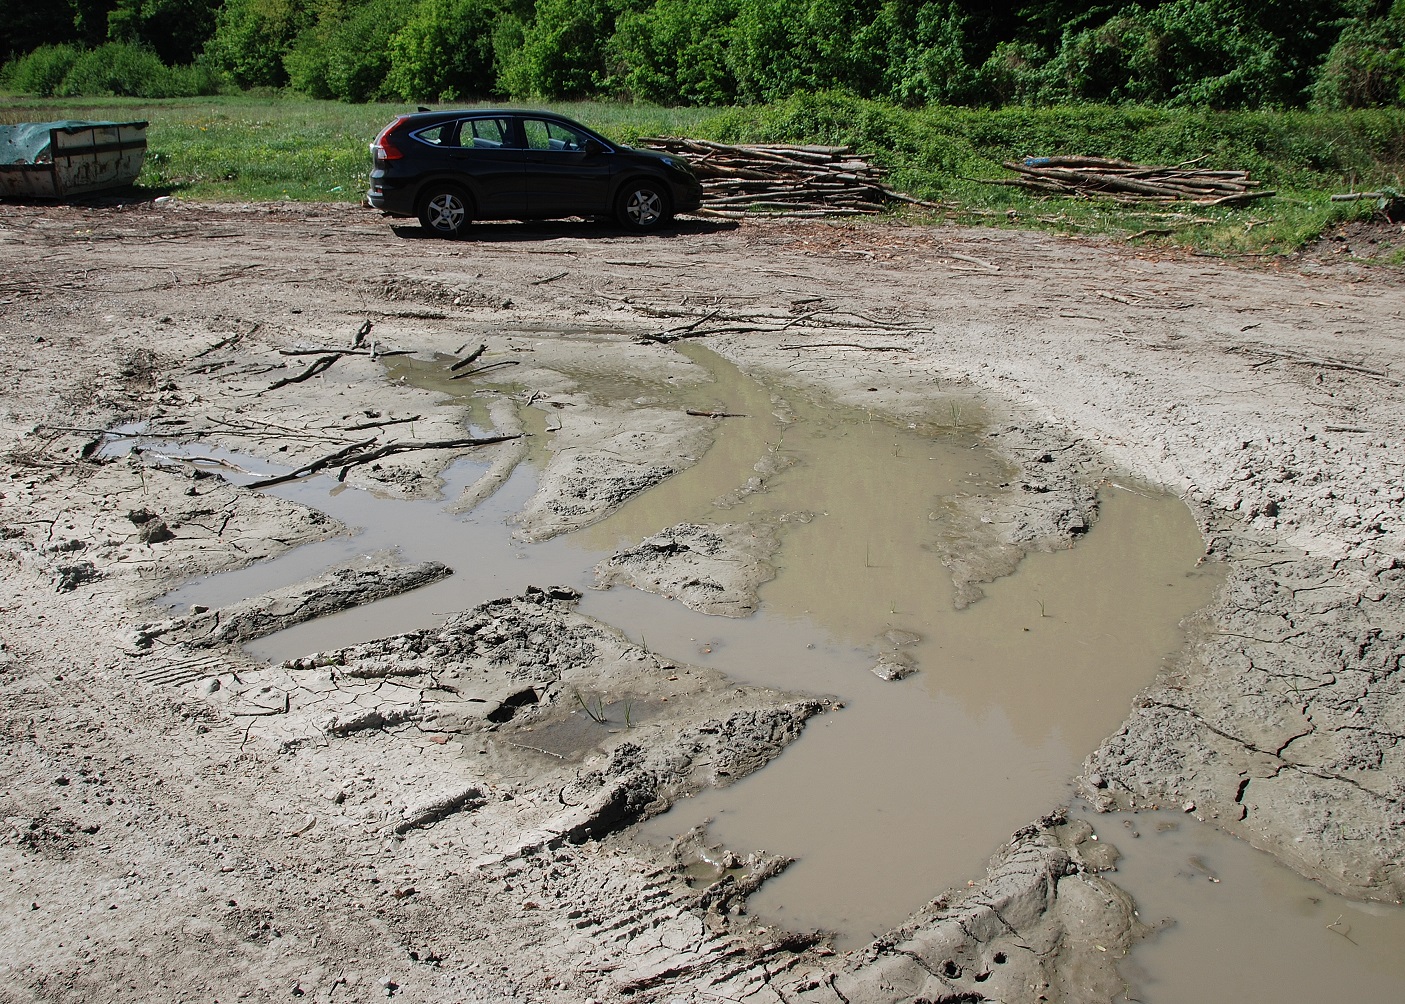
367 110 703 237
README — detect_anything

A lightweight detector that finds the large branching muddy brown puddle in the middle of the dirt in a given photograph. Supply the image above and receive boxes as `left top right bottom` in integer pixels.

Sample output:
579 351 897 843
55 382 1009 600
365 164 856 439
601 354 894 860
142 347 1398 1000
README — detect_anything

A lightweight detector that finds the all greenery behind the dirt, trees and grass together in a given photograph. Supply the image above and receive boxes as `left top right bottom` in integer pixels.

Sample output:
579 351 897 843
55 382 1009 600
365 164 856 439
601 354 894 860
0 0 1405 255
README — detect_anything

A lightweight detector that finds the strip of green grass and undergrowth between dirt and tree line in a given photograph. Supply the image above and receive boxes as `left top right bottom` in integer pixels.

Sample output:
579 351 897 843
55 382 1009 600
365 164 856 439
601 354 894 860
0 94 1405 254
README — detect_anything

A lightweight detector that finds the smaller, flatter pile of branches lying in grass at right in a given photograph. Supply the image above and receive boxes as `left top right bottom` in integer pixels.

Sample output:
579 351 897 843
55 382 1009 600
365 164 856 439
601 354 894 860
982 157 1274 205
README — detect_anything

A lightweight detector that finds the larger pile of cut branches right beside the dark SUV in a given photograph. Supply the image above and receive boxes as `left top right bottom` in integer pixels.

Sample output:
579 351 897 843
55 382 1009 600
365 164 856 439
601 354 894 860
639 138 944 219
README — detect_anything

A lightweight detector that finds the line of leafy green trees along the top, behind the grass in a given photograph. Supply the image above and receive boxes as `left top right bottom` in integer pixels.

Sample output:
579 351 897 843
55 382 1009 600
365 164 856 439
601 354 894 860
0 0 1405 108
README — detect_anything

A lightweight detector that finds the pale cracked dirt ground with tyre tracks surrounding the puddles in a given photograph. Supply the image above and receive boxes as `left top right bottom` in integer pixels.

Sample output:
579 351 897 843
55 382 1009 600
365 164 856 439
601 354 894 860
0 199 1405 1004
